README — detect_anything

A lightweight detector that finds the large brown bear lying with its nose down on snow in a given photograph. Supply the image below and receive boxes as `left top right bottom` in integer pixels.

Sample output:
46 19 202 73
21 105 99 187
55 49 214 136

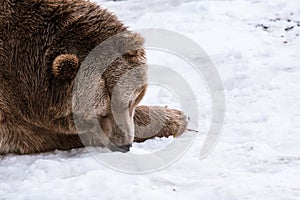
0 0 187 154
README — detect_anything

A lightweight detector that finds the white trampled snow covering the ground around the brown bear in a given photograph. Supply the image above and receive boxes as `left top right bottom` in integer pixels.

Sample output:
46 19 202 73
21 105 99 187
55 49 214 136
0 0 300 200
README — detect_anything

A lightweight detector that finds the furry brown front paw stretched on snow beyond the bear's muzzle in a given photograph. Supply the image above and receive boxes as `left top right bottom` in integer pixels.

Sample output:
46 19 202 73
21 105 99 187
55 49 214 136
134 106 187 142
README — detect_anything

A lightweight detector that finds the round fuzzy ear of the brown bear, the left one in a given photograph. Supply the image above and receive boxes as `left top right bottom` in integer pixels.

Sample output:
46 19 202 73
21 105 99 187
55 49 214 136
52 54 79 80
